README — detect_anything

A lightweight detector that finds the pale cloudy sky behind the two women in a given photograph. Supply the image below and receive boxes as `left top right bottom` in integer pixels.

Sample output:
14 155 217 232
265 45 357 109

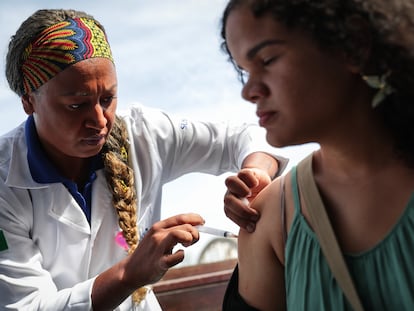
0 0 314 266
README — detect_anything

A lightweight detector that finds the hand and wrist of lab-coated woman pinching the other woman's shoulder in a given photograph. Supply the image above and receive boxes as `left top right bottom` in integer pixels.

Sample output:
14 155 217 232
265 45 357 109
224 152 279 232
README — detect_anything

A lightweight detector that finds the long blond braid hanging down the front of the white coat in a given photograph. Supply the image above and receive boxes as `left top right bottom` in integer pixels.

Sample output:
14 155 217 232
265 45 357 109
102 116 147 303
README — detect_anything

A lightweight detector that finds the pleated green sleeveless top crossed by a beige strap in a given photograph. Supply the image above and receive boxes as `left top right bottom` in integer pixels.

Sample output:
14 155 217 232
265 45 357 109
285 167 414 311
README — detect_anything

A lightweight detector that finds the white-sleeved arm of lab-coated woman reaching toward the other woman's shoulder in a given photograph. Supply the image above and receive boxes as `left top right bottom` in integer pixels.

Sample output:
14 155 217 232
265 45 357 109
131 107 257 181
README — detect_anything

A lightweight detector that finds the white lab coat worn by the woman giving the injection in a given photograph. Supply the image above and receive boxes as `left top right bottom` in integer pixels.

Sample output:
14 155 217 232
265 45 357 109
0 106 285 311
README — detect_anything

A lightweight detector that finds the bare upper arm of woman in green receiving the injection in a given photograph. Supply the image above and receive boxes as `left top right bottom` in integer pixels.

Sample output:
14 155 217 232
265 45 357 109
238 180 286 310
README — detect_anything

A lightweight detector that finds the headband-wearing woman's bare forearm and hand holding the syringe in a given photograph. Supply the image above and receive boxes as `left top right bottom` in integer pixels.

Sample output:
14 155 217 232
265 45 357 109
92 214 204 311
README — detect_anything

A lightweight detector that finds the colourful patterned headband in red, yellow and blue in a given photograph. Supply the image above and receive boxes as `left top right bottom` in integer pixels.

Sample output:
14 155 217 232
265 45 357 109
22 18 113 94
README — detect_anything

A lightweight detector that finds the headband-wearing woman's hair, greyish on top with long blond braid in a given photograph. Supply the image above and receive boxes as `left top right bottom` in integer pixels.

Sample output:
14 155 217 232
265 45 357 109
6 9 146 302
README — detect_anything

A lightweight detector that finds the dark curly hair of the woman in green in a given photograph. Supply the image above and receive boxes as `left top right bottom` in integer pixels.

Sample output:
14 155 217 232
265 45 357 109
221 0 414 167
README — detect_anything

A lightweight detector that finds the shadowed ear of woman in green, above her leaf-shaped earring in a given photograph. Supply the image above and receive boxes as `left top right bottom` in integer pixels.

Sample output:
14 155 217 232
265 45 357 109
345 15 372 74
